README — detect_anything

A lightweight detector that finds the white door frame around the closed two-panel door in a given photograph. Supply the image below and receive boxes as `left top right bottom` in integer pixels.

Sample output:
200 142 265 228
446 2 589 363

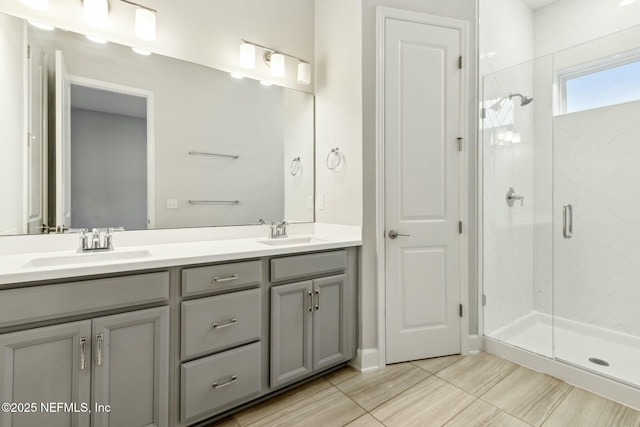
376 7 471 369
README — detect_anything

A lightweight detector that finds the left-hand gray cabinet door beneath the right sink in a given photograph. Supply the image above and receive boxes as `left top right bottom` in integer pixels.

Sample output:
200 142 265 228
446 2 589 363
270 281 313 388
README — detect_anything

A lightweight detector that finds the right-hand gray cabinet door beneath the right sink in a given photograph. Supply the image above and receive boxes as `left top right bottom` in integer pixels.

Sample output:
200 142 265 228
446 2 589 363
313 274 349 370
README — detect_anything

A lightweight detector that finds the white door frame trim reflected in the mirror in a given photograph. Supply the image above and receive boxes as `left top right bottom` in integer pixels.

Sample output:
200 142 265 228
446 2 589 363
69 74 156 230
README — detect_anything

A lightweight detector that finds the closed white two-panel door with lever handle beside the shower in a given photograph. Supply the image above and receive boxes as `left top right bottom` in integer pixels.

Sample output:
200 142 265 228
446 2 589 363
384 19 462 363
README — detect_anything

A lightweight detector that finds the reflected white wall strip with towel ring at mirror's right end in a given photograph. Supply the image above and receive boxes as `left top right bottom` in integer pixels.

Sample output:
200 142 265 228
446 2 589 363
283 90 315 222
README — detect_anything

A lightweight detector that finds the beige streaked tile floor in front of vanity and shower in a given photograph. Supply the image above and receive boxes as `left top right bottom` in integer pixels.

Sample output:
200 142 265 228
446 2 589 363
209 353 640 427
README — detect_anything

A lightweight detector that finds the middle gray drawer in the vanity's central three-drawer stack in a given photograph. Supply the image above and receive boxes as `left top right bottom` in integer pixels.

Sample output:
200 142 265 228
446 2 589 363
180 289 262 359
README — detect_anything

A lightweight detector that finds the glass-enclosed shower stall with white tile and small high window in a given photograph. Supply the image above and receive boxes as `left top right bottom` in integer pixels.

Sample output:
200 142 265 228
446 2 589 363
480 27 640 402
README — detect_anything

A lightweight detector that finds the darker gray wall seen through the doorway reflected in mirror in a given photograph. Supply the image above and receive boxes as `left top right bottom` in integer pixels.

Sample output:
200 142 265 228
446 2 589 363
71 108 147 230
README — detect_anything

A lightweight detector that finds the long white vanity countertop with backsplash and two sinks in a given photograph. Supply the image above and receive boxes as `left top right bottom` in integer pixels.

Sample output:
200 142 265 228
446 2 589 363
0 223 362 285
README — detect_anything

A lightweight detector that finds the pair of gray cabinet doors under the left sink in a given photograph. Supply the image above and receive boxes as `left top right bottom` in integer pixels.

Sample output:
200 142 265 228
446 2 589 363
0 307 169 427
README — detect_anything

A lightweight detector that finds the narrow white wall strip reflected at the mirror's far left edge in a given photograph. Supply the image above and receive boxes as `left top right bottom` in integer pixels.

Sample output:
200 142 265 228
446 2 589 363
0 15 26 235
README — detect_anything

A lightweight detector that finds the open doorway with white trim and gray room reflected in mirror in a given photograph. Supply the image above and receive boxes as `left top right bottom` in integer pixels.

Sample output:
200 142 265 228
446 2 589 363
56 52 154 229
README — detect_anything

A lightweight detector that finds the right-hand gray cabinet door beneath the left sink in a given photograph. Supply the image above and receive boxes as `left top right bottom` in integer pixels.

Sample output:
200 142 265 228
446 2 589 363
92 307 169 427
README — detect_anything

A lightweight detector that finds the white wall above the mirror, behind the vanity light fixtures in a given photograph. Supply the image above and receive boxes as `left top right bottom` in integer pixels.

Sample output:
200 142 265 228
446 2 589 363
0 0 314 92
